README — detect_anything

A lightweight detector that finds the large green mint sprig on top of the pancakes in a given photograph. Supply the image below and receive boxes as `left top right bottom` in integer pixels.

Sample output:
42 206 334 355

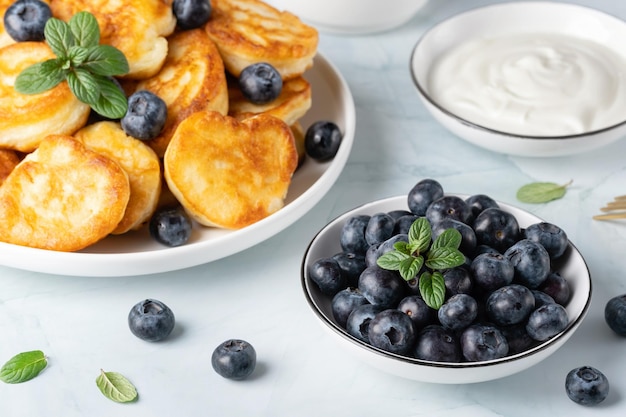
15 12 129 119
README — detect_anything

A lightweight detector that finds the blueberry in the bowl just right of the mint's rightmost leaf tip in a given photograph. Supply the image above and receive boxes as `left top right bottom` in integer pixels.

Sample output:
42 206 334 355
470 252 515 291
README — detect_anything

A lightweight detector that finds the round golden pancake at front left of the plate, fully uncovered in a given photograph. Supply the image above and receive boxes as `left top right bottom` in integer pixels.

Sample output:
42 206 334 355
0 135 130 250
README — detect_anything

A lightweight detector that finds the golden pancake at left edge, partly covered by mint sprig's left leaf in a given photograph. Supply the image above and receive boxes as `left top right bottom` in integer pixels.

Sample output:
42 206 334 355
0 42 90 152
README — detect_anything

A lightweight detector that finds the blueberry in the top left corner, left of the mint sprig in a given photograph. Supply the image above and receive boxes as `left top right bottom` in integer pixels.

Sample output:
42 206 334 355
4 0 52 42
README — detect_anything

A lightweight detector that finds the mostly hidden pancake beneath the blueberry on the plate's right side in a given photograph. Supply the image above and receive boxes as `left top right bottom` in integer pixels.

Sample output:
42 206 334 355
228 77 311 125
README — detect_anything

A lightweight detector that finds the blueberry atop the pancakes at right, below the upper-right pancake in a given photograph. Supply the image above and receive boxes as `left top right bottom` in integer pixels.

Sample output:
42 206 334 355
239 62 283 104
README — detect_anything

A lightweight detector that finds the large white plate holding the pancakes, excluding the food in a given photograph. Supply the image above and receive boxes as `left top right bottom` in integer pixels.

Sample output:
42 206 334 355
0 54 356 276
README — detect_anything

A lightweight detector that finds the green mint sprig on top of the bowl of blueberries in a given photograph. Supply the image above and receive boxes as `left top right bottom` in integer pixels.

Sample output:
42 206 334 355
376 217 465 310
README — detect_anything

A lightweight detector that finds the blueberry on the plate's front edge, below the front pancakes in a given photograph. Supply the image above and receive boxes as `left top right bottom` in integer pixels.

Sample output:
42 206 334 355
148 207 193 247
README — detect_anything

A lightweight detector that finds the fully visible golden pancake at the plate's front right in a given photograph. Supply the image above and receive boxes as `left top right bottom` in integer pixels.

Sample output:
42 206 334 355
163 111 298 229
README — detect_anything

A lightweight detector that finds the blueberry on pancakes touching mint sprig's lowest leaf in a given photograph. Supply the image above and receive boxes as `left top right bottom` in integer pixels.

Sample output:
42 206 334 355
121 90 167 140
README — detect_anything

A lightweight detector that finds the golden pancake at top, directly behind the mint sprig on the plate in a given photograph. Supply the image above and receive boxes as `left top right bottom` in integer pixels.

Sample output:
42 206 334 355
50 0 176 79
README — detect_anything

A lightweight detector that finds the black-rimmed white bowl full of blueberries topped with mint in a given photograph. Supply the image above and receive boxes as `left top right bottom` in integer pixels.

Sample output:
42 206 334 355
302 179 592 384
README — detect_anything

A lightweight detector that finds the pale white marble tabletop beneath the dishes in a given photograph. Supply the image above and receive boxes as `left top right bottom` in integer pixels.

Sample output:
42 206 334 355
0 0 626 417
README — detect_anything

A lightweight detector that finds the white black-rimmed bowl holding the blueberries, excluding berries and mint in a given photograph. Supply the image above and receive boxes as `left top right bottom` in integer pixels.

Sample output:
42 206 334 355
301 194 592 384
